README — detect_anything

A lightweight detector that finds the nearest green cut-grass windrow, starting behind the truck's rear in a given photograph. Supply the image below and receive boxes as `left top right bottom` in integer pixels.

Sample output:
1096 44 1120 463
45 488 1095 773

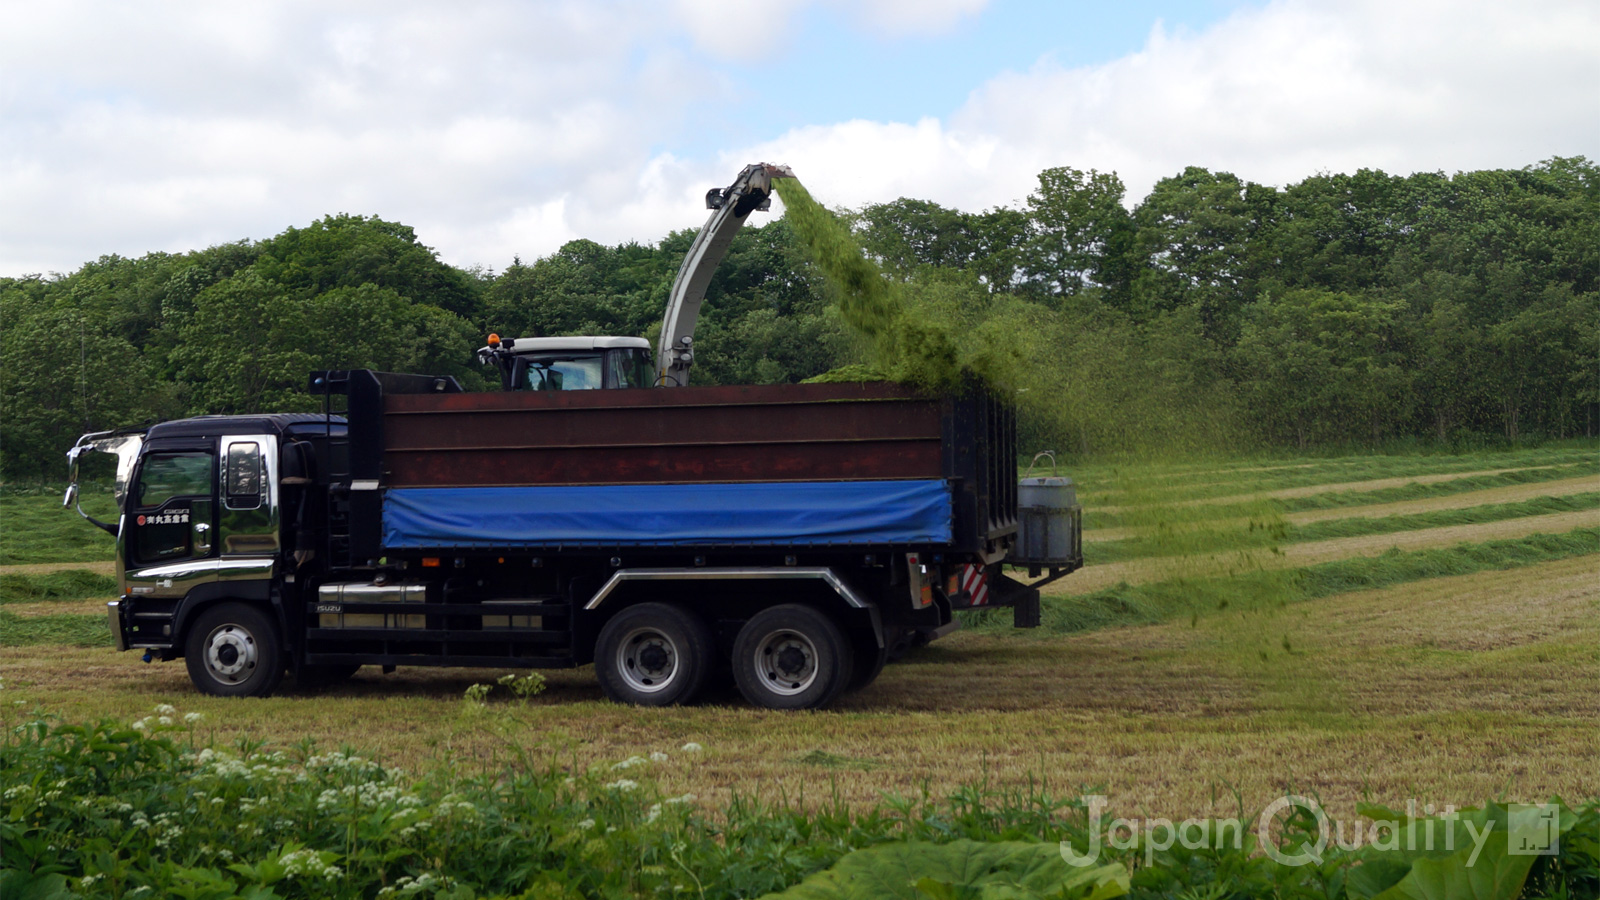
968 528 1600 634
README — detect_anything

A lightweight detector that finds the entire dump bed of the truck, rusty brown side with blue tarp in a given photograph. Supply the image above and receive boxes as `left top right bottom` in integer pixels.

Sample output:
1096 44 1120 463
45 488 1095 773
332 372 1016 556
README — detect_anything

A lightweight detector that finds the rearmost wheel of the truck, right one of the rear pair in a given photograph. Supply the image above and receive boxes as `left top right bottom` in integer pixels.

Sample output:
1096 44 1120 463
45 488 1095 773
733 604 851 709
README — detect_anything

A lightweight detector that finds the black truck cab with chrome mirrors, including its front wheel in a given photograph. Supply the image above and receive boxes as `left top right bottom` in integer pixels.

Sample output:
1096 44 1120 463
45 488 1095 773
67 413 346 693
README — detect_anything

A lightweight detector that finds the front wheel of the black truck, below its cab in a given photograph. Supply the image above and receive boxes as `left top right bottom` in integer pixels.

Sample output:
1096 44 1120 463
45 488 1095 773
184 604 283 697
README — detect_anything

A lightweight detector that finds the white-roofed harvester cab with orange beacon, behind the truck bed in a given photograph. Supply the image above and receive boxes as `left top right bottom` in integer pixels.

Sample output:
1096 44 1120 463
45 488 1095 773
478 335 656 391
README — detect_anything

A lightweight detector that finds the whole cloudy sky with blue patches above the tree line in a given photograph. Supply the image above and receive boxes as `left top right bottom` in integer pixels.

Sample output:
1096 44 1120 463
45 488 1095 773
0 0 1600 275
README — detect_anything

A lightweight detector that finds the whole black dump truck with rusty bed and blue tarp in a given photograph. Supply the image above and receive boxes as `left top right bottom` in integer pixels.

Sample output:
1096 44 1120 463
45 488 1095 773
67 370 1082 709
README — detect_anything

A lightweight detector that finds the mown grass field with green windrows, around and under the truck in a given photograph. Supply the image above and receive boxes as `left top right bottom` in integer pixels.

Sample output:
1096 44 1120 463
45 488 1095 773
0 447 1600 817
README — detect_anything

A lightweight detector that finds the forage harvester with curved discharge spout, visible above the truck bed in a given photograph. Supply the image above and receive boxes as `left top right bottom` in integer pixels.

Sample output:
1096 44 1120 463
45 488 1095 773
478 162 794 391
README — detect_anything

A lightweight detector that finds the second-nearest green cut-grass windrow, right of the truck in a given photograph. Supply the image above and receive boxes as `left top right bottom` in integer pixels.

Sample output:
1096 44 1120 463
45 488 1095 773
1091 492 1600 564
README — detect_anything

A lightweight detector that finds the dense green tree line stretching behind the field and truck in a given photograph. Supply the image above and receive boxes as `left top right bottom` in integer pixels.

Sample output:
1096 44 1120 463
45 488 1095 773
0 157 1600 479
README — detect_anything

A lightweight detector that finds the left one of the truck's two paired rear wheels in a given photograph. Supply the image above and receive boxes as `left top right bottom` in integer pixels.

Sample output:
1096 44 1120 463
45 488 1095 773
595 604 717 706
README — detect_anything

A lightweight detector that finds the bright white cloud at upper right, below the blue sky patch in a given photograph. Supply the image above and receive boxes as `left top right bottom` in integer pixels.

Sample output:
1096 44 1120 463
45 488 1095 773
733 0 1600 210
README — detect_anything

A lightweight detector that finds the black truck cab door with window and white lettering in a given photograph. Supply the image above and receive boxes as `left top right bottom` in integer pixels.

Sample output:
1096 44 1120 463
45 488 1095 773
120 447 216 586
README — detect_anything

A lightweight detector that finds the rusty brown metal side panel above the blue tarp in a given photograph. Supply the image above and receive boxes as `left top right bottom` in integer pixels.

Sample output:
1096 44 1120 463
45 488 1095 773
382 383 944 488
